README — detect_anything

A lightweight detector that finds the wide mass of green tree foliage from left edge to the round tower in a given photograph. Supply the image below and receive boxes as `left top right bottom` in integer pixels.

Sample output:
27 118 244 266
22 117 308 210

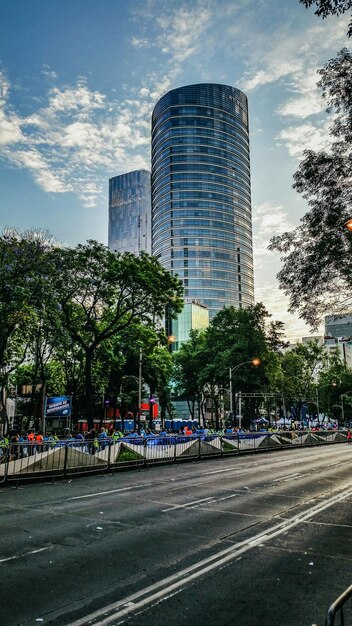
0 230 183 432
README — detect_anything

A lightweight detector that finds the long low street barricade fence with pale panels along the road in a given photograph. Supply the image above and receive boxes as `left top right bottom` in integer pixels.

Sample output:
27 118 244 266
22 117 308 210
0 431 347 482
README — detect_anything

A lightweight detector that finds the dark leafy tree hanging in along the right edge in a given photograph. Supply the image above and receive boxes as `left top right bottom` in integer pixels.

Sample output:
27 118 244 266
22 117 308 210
269 49 352 329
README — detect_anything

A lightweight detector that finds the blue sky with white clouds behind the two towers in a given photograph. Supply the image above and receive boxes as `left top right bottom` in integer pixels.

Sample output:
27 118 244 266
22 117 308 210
0 0 348 340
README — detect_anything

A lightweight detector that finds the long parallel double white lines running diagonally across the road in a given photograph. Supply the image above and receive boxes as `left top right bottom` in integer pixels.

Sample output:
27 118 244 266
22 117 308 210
69 488 352 626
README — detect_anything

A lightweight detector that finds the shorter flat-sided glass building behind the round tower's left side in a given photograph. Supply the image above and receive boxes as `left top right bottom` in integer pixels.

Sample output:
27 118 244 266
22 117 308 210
108 170 152 255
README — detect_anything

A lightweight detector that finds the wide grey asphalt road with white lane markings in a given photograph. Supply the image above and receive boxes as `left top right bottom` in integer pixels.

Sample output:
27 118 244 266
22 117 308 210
0 444 352 626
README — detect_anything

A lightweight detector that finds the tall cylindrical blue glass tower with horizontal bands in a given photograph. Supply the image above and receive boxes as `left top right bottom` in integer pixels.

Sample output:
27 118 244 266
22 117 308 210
152 84 254 317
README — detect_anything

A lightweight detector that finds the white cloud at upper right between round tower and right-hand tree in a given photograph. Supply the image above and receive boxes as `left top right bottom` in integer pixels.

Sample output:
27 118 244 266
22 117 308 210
240 18 348 158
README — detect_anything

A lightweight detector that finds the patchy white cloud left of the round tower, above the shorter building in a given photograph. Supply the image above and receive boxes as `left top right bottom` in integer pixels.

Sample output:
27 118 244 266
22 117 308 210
0 75 150 206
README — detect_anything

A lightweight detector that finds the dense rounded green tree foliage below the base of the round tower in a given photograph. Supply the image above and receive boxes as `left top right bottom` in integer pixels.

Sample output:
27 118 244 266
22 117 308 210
174 303 285 427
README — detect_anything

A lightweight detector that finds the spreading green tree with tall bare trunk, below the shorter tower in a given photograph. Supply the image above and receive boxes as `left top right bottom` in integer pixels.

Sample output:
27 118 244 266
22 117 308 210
55 241 183 428
